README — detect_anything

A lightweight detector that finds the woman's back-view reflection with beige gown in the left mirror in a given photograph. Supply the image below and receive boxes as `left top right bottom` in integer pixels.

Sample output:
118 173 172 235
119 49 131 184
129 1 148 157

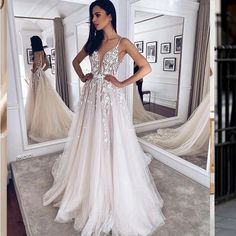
26 36 73 142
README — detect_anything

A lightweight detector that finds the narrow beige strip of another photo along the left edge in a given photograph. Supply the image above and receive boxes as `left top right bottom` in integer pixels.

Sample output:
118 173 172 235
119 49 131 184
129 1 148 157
0 0 8 235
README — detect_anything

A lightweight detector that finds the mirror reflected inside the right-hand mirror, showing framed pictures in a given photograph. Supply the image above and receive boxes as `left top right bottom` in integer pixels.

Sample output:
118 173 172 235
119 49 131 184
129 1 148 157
133 11 184 124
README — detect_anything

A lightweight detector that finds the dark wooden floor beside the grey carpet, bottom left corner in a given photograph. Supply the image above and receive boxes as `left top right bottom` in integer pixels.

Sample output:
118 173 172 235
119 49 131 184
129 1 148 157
7 181 26 236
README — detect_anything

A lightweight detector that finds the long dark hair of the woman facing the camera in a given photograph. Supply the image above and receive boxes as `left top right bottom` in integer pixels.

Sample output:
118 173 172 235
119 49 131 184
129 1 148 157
84 0 116 56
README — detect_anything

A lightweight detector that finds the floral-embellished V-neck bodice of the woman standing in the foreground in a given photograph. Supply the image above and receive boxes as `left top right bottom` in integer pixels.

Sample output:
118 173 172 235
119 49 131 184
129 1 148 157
89 45 120 78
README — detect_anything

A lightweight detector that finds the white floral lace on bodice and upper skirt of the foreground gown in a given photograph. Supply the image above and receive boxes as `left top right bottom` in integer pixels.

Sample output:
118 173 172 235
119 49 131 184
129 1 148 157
80 42 125 144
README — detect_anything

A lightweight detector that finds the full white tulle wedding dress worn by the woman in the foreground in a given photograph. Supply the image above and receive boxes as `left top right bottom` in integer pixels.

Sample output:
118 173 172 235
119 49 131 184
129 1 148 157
43 39 164 236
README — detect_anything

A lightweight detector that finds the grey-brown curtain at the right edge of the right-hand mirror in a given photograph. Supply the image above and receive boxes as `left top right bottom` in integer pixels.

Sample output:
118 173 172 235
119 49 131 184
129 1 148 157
189 0 210 116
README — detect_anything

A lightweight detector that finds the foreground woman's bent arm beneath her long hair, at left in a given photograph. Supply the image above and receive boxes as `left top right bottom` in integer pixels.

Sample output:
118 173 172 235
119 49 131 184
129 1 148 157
72 48 92 82
